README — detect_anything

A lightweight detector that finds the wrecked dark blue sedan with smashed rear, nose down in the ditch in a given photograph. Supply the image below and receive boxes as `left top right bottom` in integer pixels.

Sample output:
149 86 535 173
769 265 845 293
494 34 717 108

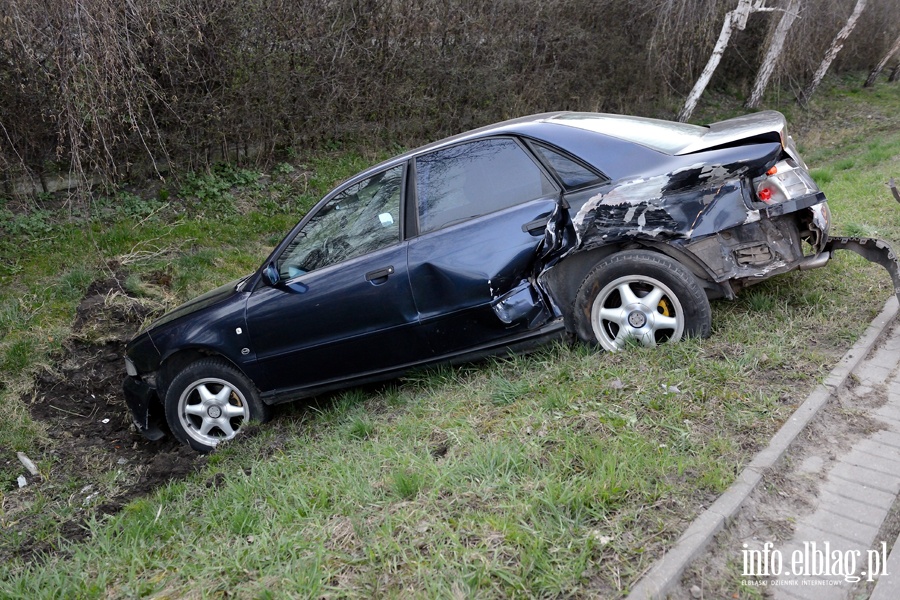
124 111 900 452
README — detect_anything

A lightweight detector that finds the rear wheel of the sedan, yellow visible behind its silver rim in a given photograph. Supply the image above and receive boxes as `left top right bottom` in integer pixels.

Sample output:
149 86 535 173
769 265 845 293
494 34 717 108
573 250 711 352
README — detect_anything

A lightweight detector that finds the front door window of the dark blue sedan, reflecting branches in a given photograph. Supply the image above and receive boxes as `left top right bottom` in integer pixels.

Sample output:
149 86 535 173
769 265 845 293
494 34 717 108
278 165 403 279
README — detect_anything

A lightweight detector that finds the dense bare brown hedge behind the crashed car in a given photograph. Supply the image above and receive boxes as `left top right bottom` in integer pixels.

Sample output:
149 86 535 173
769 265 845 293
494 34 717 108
0 0 900 199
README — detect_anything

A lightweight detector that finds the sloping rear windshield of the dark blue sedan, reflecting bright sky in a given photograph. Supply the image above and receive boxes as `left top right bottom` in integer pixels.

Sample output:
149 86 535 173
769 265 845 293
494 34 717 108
551 113 709 154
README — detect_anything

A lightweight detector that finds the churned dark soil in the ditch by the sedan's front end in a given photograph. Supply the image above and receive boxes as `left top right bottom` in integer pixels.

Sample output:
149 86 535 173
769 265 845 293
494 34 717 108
0 274 204 561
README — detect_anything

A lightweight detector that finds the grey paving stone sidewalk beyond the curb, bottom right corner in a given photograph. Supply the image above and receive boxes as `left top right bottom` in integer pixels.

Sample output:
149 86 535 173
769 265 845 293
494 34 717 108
768 316 900 600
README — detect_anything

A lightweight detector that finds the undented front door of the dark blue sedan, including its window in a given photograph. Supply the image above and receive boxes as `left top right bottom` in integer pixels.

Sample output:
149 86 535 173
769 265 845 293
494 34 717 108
247 165 427 391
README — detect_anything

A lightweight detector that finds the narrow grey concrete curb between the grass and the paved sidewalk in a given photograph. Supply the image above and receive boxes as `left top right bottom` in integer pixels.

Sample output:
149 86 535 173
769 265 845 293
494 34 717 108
627 296 900 600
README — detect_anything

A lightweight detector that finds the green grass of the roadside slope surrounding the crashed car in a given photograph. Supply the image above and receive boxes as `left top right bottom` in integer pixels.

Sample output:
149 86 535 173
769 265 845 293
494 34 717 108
0 77 900 598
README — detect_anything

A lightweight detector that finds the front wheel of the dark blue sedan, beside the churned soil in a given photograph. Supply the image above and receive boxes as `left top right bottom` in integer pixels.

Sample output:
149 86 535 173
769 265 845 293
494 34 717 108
165 358 269 452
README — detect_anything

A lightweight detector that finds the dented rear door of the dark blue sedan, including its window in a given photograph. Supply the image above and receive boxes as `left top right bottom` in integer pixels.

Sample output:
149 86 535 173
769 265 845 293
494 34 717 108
409 137 560 356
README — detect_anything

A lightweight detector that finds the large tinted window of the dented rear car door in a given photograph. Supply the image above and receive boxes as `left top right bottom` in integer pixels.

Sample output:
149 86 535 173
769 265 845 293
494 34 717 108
416 138 557 233
